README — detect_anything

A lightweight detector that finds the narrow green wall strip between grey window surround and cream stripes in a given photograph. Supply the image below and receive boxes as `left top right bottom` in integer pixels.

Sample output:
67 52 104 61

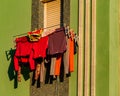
69 0 79 96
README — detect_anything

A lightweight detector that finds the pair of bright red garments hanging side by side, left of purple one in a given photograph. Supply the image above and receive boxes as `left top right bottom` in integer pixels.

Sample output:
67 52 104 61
14 36 48 71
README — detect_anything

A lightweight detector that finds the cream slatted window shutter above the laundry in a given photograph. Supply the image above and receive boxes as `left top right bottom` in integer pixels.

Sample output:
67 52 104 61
44 0 60 29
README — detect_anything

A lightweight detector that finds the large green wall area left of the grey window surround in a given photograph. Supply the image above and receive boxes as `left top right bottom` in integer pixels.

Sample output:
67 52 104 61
0 0 31 96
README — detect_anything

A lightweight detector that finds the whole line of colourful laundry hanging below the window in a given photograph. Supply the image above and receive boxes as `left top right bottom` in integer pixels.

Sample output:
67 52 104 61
14 27 78 87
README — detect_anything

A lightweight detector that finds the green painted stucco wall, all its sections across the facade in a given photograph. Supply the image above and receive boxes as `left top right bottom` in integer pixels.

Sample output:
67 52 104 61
0 0 120 96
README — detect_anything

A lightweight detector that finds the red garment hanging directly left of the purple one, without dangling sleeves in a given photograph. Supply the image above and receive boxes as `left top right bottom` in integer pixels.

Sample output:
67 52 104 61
32 36 48 59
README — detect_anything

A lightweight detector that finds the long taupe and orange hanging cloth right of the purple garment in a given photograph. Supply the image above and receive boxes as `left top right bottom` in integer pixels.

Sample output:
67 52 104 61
63 31 75 74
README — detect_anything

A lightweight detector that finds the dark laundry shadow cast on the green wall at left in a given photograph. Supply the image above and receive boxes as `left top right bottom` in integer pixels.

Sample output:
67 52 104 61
5 48 30 89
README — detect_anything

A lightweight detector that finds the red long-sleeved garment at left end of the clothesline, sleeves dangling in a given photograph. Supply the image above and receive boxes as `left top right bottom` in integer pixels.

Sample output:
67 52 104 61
14 36 35 71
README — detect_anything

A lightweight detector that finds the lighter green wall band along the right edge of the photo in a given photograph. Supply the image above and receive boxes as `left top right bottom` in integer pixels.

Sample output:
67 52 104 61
109 0 120 96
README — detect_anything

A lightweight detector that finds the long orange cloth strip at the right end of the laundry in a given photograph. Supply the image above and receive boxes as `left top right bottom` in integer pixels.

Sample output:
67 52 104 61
69 38 74 72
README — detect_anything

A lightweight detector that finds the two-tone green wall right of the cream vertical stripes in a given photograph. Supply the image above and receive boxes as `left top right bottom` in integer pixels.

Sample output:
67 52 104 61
96 0 120 96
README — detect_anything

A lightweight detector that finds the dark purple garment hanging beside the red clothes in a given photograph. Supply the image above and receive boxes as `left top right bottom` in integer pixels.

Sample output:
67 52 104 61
48 28 66 55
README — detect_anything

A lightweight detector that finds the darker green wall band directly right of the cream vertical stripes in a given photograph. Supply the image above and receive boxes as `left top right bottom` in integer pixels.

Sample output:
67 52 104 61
96 0 109 96
